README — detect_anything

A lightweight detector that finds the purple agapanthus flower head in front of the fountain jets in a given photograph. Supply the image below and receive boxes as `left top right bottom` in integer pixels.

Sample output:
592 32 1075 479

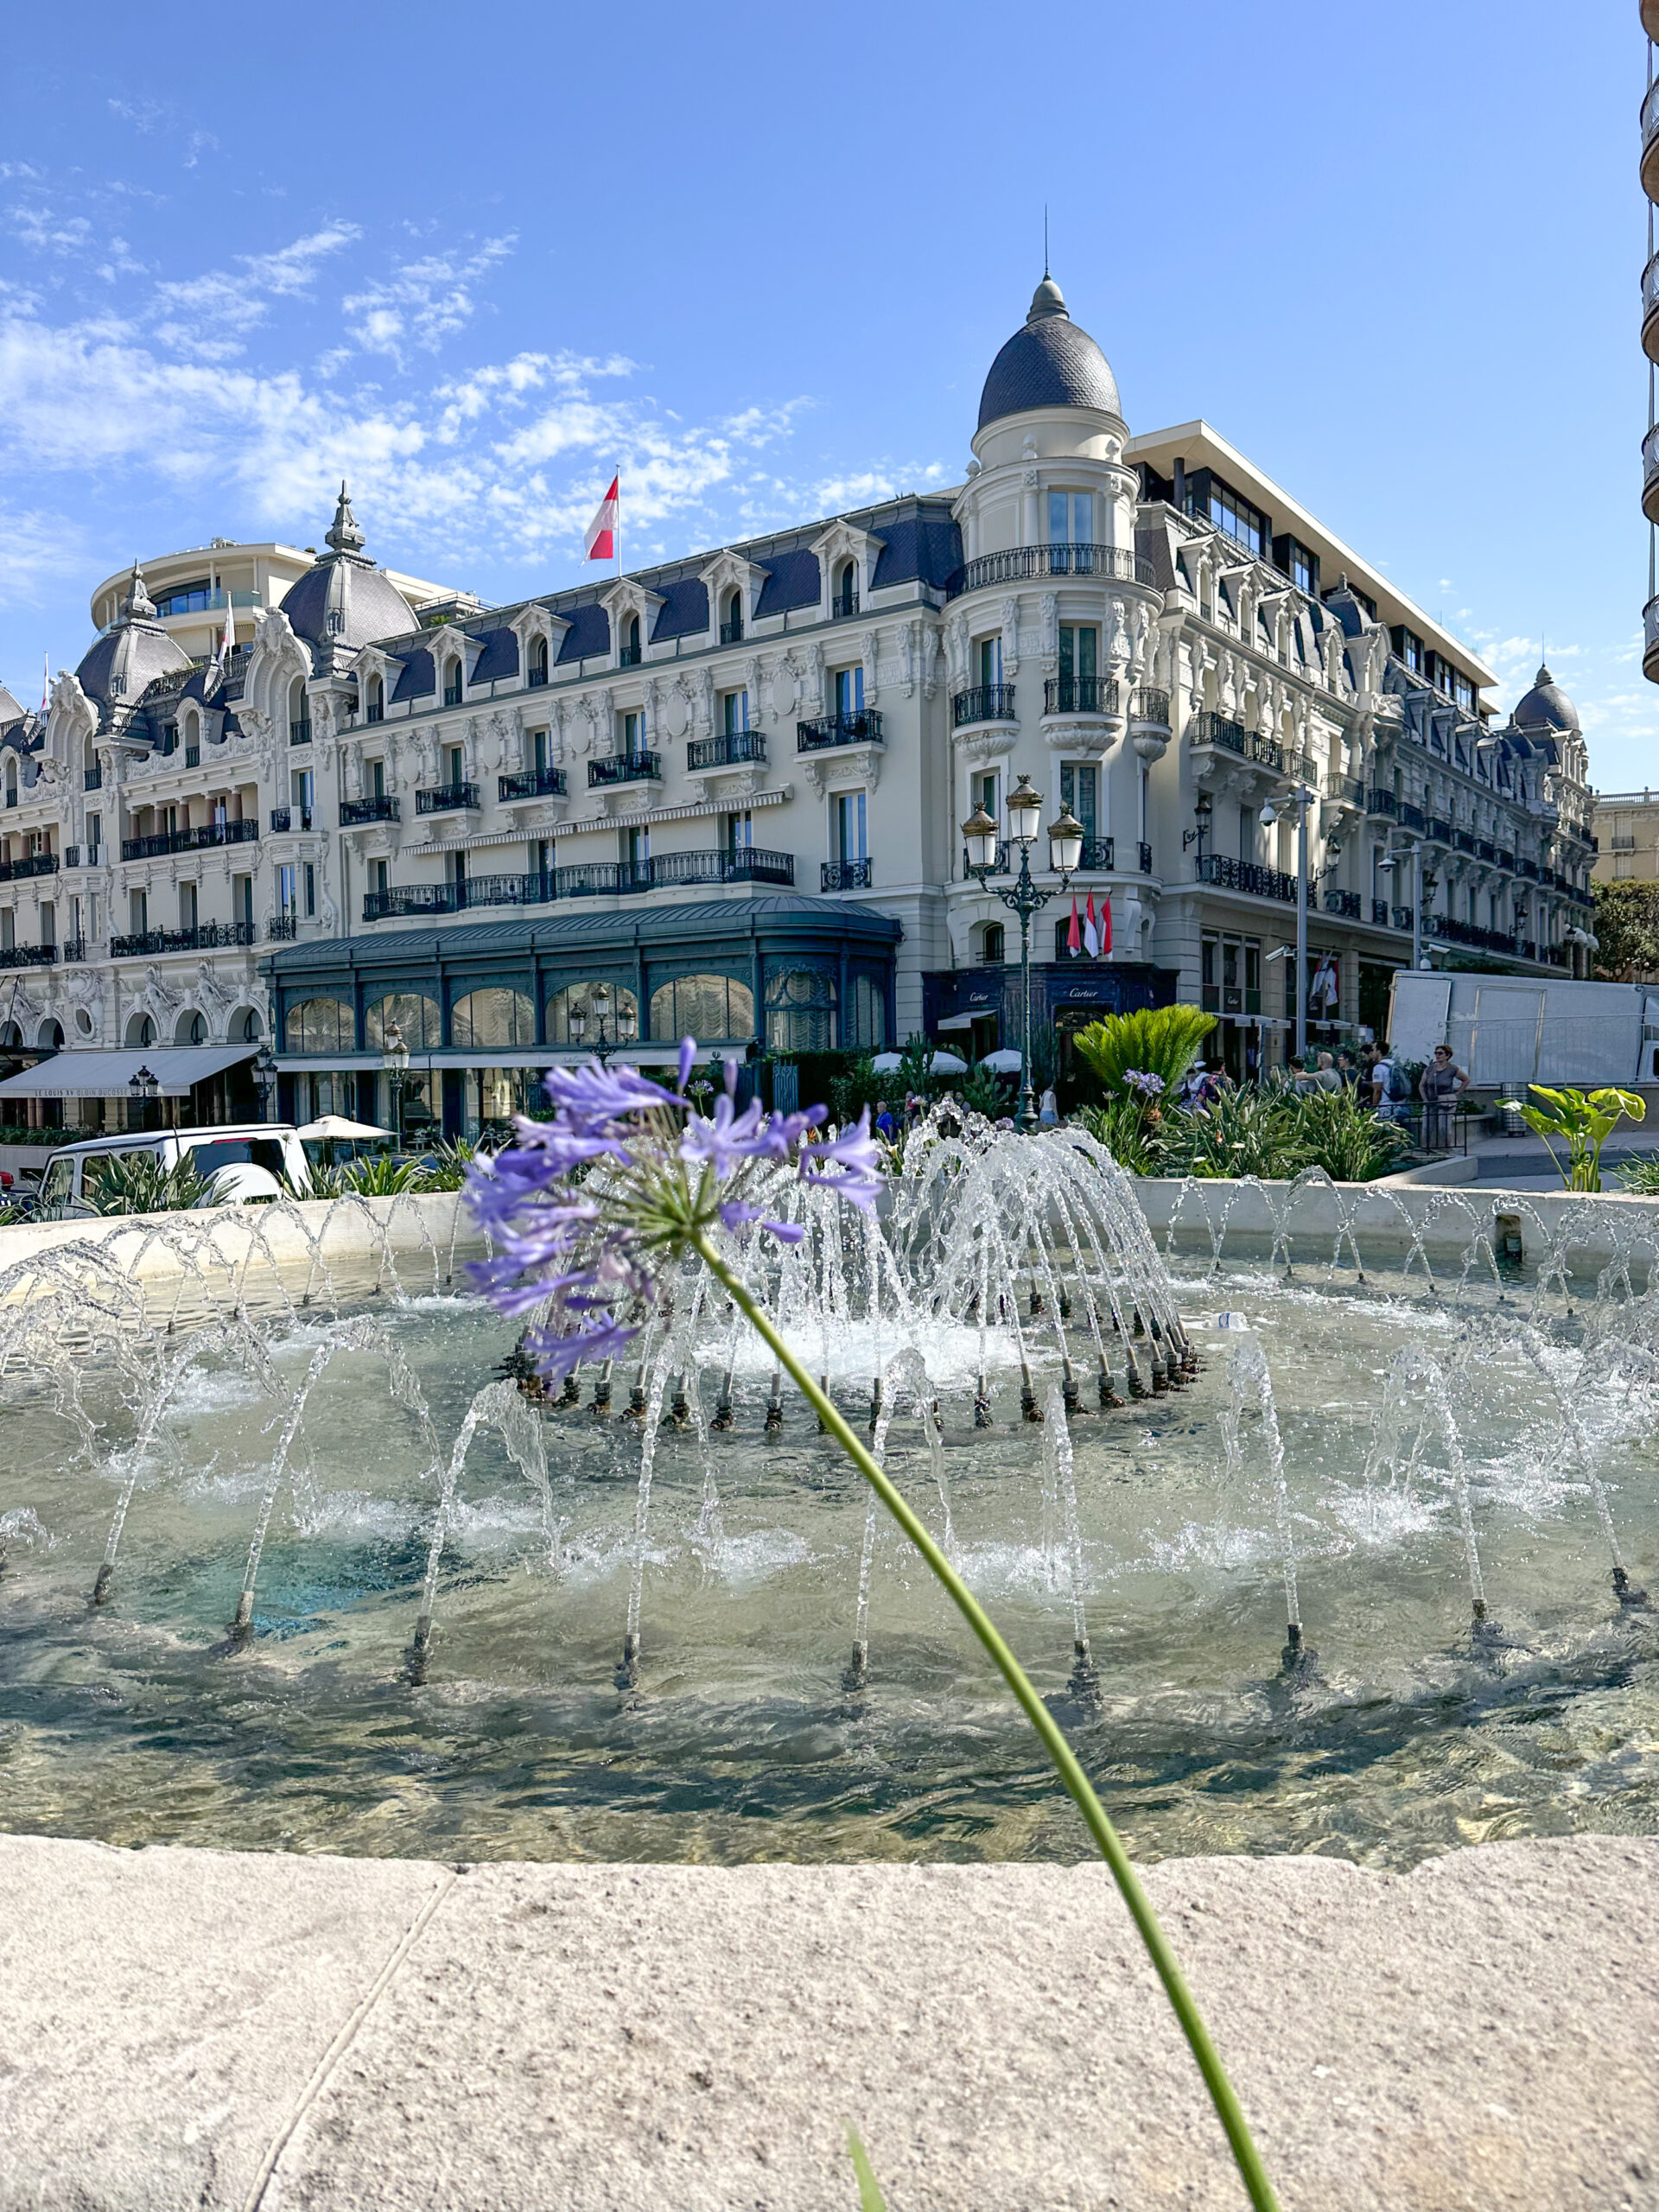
465 1038 880 1378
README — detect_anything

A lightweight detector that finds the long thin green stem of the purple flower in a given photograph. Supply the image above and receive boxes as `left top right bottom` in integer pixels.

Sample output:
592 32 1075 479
695 1234 1279 2212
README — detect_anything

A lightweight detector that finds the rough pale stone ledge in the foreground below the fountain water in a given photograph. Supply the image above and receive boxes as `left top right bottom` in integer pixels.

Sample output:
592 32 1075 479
0 1836 1659 2212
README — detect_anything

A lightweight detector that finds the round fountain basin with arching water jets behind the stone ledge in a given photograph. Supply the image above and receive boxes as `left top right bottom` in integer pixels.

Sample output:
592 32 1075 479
0 1113 1659 1863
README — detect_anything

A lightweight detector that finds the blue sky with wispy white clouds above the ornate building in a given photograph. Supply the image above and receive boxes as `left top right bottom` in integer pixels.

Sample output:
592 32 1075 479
0 0 1659 787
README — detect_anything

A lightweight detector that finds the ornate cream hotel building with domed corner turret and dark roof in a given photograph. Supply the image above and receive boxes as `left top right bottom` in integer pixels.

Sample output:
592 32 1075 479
0 276 1591 1130
